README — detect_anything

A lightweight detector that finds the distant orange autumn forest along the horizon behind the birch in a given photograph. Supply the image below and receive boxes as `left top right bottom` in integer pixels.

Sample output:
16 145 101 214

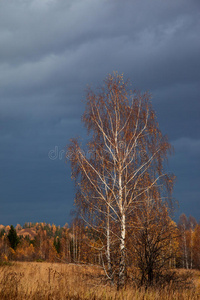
0 214 200 269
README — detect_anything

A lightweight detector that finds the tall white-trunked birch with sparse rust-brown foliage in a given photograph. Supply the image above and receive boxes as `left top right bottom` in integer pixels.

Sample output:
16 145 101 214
67 73 173 288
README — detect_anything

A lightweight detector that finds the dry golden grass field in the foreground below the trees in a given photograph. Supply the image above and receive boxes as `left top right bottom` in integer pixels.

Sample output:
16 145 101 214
0 262 200 300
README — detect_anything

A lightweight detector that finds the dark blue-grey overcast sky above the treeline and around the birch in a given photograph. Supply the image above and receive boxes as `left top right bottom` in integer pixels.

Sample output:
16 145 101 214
0 0 200 225
